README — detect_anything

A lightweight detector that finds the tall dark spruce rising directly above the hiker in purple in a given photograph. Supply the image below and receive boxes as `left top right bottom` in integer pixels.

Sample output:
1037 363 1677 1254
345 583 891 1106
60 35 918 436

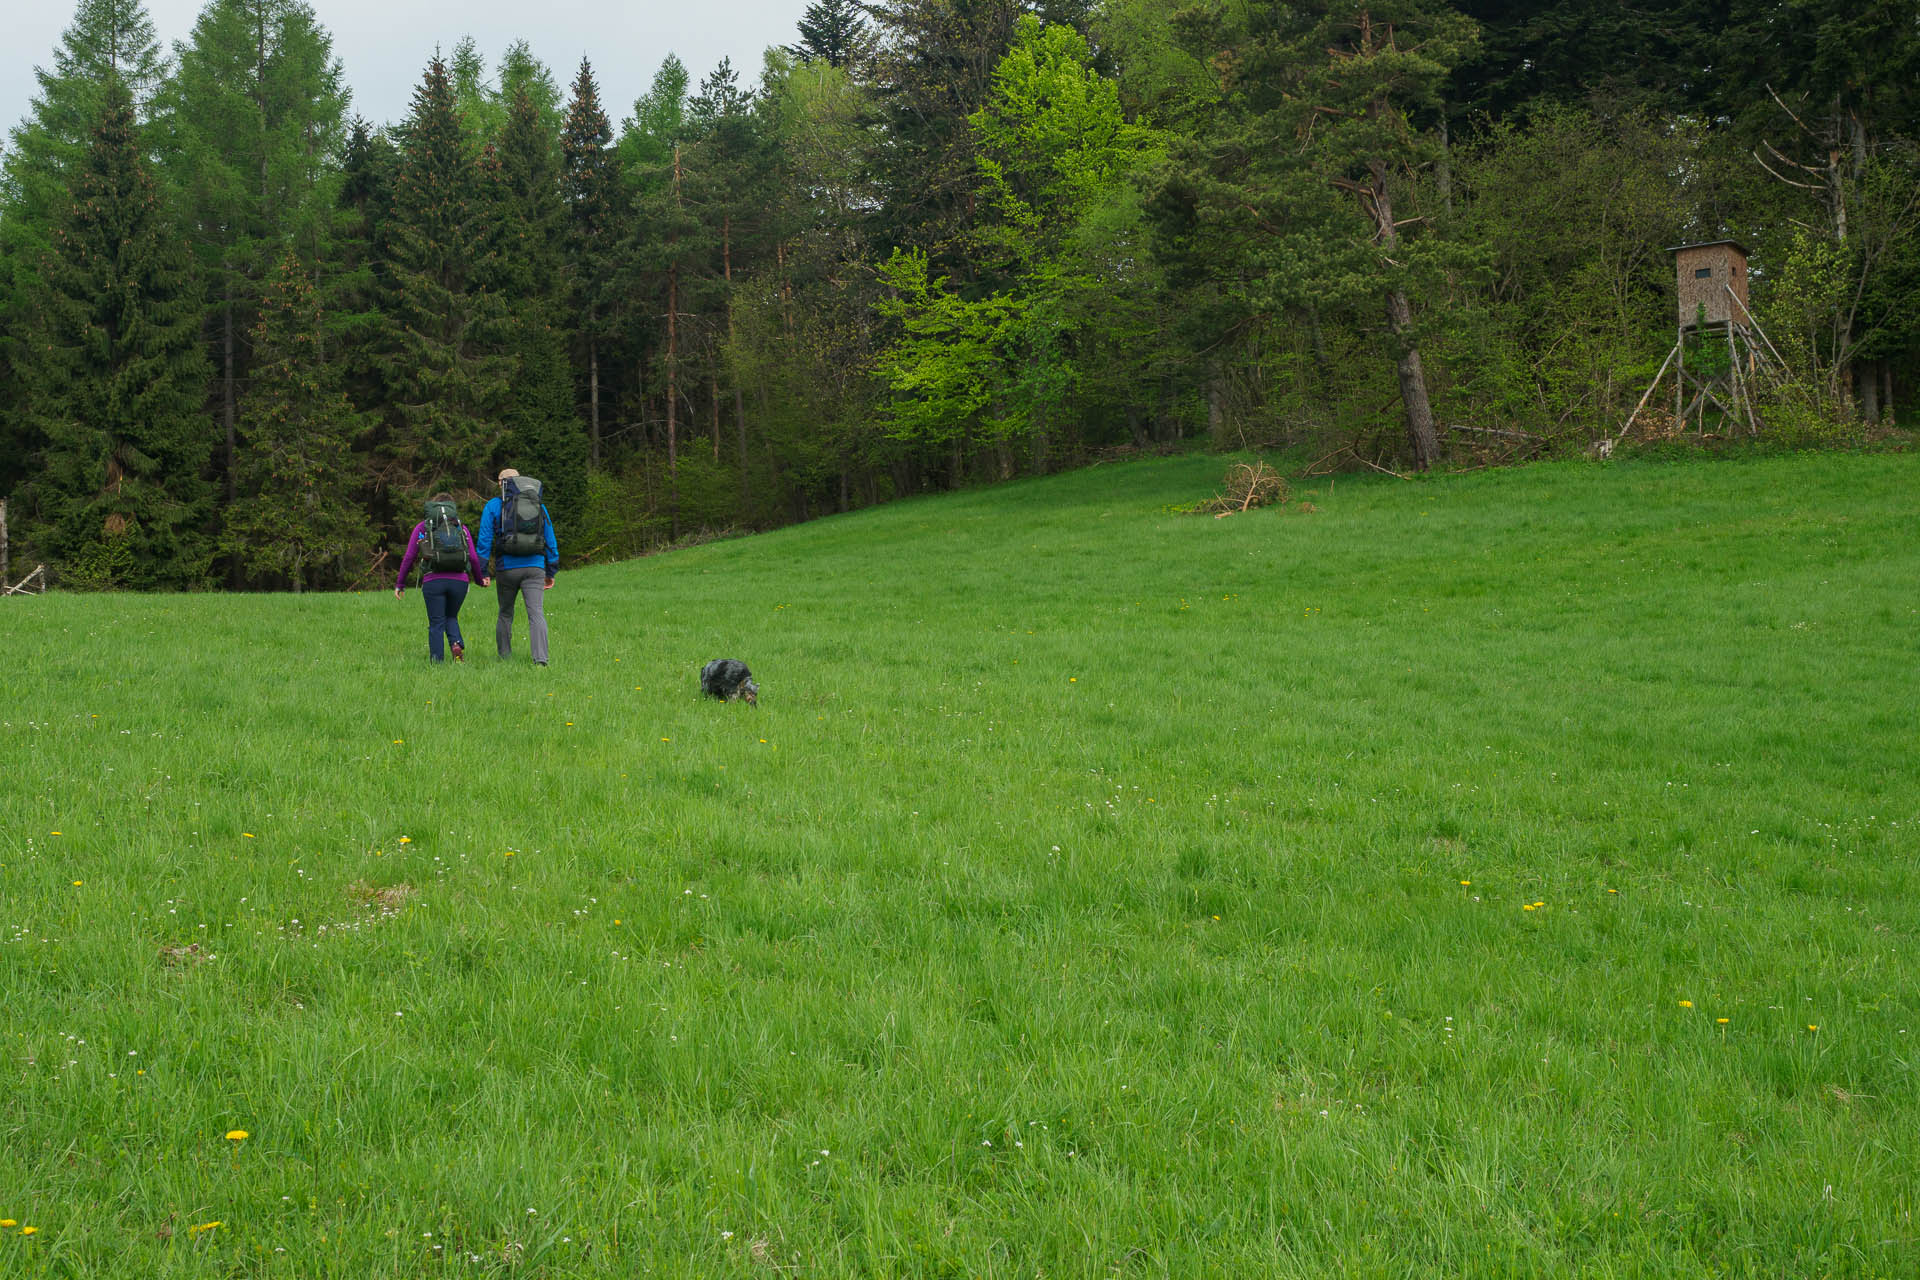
382 61 513 489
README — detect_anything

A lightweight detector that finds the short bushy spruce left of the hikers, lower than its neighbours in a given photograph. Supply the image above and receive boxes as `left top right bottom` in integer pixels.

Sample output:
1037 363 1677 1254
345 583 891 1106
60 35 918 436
223 253 374 591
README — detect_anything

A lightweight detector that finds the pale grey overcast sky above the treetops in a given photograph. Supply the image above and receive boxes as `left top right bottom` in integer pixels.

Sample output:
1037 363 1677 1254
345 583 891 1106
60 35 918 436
0 0 806 132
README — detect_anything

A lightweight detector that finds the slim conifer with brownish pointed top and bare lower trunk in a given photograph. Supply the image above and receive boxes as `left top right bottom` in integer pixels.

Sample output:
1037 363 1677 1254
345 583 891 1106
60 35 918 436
561 58 620 466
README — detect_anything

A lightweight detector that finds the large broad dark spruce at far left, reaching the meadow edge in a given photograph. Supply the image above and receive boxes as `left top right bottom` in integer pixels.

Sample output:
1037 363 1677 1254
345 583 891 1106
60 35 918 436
19 81 213 587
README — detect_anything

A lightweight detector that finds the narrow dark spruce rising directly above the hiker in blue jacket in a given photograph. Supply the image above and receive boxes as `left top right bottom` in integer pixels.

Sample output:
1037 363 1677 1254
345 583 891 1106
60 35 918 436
495 84 588 524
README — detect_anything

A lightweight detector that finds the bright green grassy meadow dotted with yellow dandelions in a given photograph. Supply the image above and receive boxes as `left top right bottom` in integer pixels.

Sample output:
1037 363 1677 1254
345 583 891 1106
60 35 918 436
0 457 1920 1278
